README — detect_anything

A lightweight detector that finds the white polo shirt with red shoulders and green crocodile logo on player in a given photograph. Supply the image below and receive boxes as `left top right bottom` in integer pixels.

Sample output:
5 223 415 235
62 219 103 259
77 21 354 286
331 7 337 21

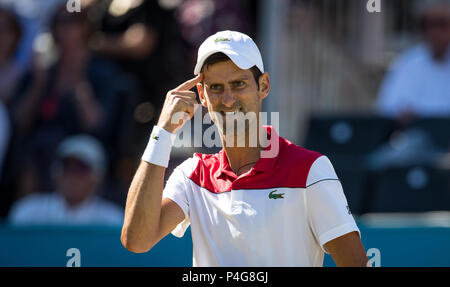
163 127 359 266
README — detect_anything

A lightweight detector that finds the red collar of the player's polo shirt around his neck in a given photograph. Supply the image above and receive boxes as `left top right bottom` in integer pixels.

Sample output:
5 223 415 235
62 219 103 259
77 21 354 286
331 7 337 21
216 126 281 177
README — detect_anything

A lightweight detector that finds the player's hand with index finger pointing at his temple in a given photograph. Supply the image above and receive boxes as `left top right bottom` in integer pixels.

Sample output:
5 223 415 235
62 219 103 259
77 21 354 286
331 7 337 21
157 73 203 133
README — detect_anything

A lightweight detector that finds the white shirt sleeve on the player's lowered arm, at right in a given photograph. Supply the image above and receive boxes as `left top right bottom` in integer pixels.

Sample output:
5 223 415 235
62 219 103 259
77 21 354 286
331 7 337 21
305 156 360 253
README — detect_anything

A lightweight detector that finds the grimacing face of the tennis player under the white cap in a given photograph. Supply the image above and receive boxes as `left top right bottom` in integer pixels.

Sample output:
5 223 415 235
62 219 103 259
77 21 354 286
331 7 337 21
198 60 270 141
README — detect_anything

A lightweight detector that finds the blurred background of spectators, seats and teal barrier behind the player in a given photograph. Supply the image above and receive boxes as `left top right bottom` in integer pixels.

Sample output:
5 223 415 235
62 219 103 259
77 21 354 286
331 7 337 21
0 0 450 266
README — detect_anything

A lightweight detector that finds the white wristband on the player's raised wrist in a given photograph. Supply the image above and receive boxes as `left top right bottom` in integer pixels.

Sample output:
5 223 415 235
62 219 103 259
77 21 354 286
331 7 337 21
141 126 177 167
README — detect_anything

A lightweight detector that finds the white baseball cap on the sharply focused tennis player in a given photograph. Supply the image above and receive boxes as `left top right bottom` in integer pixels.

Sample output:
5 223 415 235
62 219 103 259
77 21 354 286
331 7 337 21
194 30 264 75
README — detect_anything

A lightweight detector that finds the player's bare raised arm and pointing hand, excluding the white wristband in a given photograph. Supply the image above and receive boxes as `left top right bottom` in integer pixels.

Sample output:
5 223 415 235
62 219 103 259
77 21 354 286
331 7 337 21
121 74 201 253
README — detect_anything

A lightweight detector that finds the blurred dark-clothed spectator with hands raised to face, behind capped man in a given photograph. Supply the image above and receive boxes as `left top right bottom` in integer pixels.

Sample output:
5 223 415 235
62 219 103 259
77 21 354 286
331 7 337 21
8 4 132 197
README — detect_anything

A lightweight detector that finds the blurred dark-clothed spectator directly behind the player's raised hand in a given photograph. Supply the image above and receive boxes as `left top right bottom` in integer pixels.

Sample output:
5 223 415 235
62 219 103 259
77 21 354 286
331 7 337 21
89 0 187 199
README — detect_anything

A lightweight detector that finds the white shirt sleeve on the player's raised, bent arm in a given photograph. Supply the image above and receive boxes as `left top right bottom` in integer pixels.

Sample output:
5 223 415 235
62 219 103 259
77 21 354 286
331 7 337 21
163 168 190 237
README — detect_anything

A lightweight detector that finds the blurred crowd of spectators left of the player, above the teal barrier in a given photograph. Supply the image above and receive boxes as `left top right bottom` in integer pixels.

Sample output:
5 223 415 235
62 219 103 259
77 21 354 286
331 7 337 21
0 0 256 224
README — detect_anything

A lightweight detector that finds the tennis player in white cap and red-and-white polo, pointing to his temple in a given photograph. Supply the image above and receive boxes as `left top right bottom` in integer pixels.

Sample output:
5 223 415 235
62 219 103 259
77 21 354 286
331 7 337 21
121 31 368 266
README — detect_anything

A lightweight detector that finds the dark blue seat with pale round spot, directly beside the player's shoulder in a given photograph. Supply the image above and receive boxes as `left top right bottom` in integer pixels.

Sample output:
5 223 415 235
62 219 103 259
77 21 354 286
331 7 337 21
304 115 395 214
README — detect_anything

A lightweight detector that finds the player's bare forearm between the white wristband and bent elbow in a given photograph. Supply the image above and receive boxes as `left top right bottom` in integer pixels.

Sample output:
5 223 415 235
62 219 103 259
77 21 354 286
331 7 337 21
121 161 165 252
